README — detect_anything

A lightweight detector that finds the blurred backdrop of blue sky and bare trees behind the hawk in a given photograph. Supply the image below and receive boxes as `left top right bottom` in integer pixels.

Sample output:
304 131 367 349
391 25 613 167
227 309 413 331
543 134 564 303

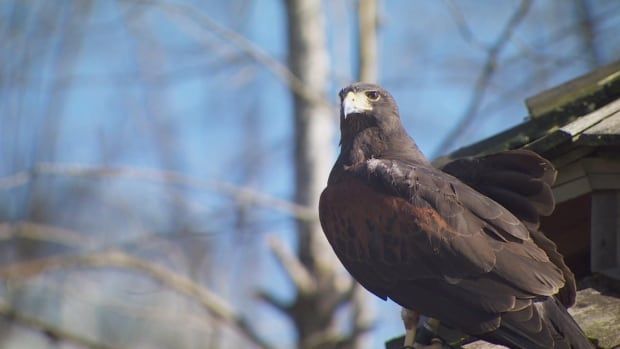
0 0 620 348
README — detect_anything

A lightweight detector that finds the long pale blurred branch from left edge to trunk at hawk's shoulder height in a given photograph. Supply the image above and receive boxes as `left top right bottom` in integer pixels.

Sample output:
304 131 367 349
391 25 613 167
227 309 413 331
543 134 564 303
0 163 316 220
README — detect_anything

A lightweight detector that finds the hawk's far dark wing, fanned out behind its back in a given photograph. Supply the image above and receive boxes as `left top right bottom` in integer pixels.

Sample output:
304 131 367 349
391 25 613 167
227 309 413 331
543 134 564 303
442 149 577 307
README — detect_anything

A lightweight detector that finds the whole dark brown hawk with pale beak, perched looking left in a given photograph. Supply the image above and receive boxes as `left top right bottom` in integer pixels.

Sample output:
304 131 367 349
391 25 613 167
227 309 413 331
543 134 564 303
319 83 591 349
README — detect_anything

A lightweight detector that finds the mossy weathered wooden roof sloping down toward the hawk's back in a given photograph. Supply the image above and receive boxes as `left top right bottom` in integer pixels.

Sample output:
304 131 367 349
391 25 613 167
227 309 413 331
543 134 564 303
435 61 620 165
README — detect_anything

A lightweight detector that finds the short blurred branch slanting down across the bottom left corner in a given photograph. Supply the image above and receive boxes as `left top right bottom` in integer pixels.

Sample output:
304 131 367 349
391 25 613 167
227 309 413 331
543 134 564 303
0 301 121 349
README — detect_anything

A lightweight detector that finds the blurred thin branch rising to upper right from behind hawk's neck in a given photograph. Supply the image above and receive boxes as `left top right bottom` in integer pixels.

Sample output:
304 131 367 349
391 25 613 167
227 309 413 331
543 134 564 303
433 0 531 157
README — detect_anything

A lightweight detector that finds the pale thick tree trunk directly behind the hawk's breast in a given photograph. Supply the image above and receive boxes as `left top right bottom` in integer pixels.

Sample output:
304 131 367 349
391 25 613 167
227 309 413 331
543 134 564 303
286 0 352 348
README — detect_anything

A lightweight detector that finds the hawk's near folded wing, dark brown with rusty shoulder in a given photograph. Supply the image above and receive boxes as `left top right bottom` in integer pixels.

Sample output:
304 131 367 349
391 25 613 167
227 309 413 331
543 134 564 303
320 156 564 347
